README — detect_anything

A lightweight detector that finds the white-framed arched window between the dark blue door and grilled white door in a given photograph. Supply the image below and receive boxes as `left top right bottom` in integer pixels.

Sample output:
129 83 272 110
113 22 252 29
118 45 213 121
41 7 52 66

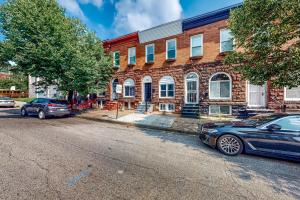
159 76 175 98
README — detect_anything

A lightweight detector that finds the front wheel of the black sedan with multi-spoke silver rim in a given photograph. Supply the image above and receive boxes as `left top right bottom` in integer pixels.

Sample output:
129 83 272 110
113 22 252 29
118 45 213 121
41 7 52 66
217 135 243 156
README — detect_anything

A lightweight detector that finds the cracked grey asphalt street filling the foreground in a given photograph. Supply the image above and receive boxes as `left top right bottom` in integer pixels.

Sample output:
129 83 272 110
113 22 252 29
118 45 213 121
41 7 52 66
0 108 300 200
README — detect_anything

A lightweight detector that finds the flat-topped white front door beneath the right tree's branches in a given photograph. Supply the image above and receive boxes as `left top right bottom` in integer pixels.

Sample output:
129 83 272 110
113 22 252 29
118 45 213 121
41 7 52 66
248 83 266 108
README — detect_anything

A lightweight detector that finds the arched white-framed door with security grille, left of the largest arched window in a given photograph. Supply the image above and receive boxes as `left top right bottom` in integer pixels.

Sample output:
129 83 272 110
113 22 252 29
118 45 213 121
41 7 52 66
185 73 199 104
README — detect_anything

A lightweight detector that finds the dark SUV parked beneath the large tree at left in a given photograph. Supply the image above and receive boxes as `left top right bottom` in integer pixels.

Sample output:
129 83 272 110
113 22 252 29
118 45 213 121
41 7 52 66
21 98 71 119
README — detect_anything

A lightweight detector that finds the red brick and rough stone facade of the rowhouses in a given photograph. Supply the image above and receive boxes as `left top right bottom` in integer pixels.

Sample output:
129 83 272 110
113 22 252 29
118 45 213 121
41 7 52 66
104 20 300 115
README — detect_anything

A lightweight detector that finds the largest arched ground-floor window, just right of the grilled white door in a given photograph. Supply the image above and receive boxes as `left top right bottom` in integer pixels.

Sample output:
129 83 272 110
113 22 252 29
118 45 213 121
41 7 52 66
209 73 231 99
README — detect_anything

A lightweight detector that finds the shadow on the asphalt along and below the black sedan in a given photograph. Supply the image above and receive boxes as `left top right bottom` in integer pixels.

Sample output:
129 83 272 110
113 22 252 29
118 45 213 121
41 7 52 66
140 125 300 199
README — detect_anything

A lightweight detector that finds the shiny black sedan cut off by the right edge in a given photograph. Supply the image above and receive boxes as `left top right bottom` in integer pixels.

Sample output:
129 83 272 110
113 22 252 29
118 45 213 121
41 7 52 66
199 114 300 161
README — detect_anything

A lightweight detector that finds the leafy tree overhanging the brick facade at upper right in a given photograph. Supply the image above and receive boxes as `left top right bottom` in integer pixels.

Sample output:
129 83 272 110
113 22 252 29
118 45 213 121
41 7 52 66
225 0 300 88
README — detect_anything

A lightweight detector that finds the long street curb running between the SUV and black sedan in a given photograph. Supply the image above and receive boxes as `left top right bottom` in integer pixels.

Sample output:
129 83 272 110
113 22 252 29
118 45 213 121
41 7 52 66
75 115 198 135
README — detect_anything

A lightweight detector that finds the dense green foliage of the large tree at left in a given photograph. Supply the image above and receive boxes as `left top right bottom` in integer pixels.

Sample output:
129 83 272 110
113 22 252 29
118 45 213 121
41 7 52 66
0 0 112 94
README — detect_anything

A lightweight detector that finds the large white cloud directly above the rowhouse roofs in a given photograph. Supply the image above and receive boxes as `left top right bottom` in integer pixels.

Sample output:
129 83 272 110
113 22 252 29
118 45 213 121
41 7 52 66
114 0 182 34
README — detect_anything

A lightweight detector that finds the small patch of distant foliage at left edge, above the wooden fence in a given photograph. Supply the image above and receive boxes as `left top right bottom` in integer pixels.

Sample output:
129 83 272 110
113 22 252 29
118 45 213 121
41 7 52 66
0 75 28 91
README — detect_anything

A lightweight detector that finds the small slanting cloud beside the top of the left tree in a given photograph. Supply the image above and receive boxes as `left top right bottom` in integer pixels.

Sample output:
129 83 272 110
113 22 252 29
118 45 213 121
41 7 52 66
58 0 88 22
